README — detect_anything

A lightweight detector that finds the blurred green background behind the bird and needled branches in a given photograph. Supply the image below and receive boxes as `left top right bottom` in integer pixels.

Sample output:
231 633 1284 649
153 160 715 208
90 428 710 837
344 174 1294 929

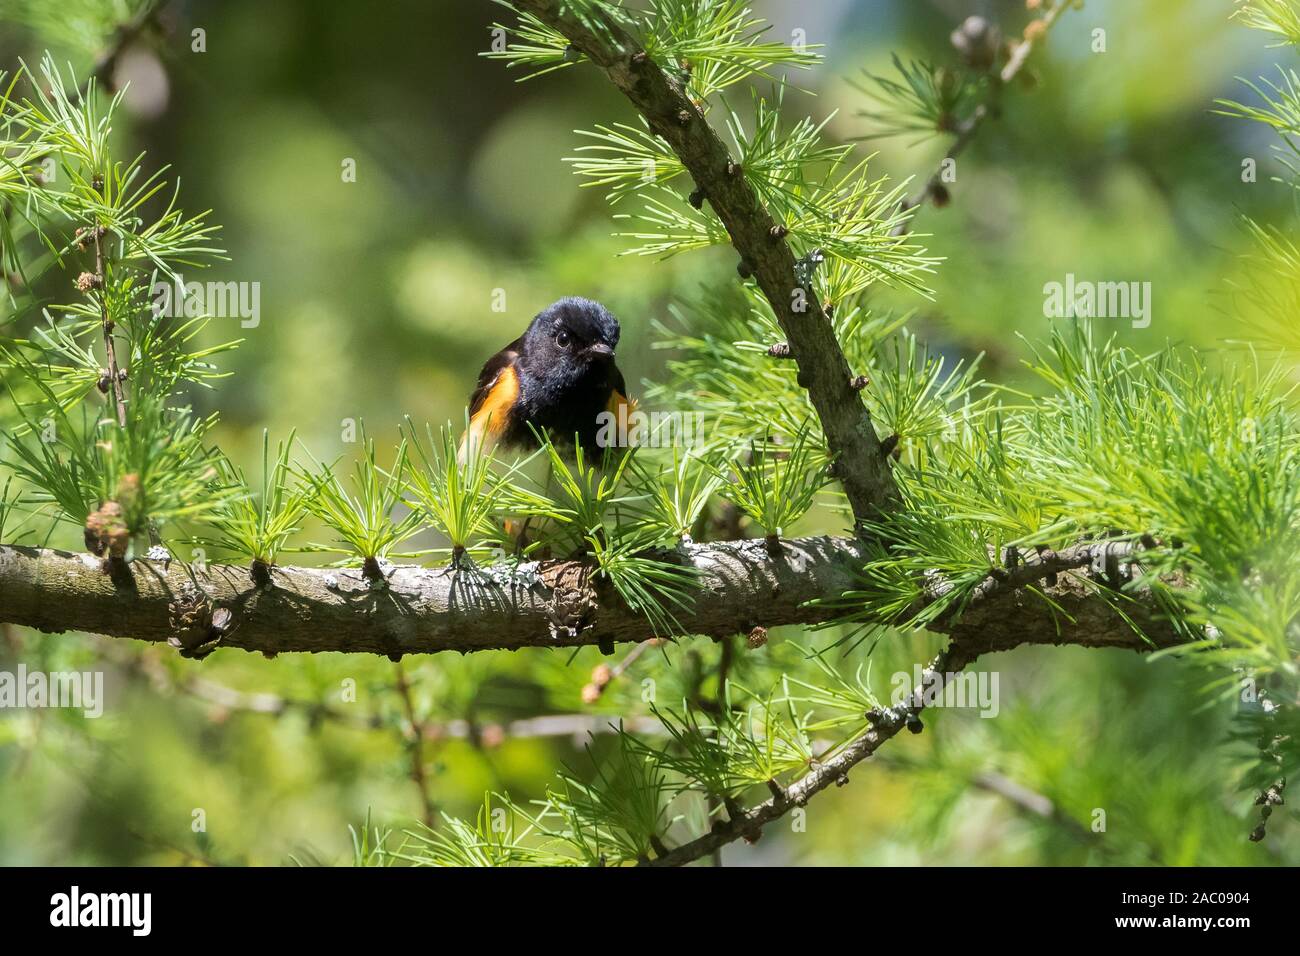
0 0 1300 865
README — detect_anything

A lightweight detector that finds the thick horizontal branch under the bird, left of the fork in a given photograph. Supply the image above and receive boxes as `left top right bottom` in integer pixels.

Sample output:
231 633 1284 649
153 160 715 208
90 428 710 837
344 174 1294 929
0 537 866 657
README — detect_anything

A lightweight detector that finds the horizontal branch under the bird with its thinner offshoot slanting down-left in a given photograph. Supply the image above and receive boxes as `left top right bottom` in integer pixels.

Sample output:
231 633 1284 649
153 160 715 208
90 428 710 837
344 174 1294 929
0 537 1182 865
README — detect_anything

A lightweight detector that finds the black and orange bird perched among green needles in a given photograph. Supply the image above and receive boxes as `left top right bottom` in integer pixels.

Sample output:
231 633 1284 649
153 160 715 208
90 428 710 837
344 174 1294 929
460 297 632 462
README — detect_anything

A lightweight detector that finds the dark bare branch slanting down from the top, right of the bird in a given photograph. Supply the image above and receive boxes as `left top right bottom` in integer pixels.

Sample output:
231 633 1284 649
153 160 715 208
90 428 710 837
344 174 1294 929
514 0 897 523
